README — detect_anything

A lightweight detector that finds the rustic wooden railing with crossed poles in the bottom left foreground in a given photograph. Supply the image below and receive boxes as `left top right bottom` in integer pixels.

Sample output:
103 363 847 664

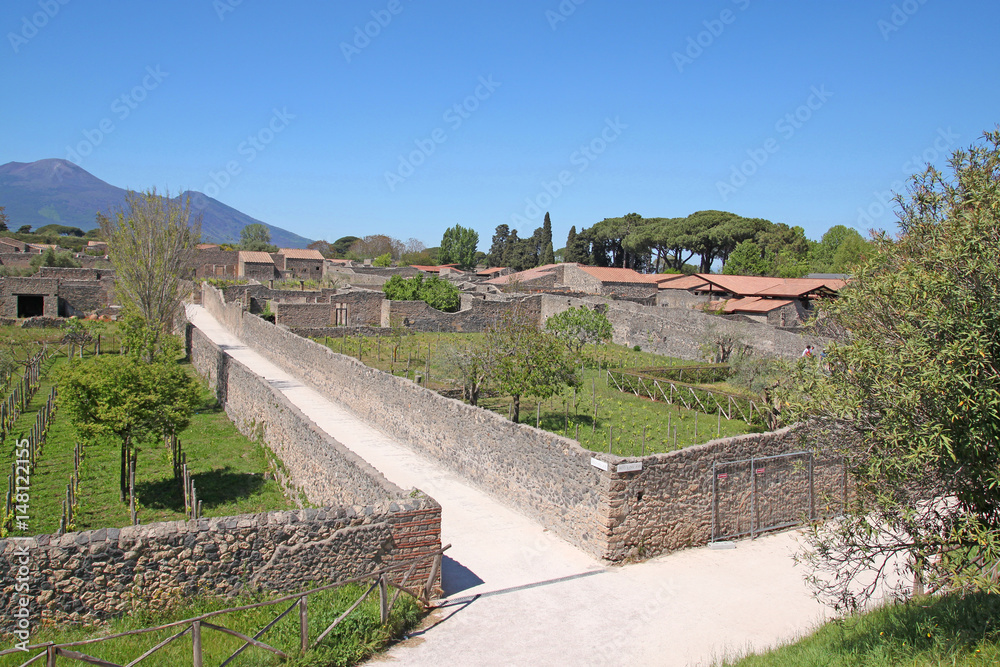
0 544 451 667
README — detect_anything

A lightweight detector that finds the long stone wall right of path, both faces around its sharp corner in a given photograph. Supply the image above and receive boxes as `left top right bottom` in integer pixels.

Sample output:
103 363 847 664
197 287 843 562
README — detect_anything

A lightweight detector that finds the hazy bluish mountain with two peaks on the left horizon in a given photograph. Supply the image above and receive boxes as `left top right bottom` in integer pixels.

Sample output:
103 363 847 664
0 159 311 248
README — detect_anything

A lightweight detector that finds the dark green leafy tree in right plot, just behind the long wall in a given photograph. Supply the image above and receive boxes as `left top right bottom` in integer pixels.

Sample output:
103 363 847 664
484 308 579 422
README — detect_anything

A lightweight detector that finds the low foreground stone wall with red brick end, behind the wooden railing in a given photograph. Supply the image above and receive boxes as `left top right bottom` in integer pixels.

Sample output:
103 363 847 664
0 506 440 631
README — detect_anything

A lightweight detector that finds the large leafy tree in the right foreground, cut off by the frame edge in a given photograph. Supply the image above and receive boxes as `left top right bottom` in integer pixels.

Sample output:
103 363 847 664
793 131 1000 607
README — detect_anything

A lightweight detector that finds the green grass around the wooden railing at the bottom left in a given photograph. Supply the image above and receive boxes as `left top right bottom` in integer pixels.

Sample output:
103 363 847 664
0 584 423 667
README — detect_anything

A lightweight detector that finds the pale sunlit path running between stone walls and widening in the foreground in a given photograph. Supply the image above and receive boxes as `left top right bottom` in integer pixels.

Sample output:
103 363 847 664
188 306 829 666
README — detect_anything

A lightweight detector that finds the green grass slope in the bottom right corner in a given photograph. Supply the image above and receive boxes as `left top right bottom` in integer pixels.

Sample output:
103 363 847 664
719 593 1000 667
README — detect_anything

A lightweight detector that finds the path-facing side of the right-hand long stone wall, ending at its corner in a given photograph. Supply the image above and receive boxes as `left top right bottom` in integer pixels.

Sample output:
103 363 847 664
202 285 607 557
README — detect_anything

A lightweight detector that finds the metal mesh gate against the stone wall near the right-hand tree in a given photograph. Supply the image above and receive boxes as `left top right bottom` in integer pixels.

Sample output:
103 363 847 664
712 452 816 542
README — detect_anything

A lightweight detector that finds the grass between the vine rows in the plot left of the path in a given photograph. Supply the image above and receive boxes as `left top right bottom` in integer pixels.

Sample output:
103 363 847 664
0 327 296 535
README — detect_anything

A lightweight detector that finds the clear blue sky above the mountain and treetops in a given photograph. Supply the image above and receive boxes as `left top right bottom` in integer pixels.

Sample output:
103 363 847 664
0 0 1000 250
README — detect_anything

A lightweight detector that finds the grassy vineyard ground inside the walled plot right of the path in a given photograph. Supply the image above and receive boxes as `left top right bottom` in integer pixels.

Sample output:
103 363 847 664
319 333 760 456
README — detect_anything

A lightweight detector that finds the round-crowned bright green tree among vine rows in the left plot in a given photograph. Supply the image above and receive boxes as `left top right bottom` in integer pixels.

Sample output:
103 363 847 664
59 354 200 501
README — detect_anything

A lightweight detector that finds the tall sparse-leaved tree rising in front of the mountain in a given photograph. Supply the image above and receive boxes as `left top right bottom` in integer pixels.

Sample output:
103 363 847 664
99 190 201 342
